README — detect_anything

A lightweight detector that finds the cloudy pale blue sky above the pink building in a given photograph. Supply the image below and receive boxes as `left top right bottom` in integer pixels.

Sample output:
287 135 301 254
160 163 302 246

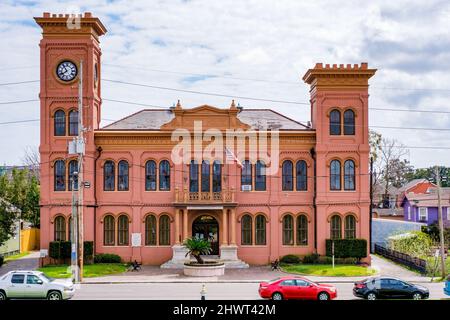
0 0 450 167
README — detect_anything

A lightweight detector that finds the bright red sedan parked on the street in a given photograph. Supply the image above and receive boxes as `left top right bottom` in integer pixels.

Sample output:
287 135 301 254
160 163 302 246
259 277 337 300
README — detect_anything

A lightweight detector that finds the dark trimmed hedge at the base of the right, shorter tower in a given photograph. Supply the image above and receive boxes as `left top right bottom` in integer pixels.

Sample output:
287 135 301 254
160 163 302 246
326 239 367 259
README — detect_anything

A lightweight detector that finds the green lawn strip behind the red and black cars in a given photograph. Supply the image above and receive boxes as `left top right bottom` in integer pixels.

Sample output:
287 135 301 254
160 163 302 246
281 264 376 277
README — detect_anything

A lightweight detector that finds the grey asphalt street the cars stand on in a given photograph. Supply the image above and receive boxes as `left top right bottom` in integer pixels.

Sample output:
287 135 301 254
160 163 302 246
73 283 450 300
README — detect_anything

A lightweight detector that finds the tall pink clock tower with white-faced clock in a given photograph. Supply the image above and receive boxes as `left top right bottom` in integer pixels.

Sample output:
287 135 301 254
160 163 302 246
35 12 106 249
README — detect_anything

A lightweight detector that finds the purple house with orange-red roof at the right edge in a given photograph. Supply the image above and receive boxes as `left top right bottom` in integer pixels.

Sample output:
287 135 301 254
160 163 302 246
401 190 450 227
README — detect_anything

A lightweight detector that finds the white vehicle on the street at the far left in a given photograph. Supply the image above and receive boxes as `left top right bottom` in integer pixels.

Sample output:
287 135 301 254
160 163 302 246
0 270 75 300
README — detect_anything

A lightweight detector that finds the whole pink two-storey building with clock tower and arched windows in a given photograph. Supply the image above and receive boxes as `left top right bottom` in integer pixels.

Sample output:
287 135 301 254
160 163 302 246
35 13 376 267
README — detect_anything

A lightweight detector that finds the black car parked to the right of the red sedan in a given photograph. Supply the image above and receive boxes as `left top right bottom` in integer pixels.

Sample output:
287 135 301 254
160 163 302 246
353 277 430 300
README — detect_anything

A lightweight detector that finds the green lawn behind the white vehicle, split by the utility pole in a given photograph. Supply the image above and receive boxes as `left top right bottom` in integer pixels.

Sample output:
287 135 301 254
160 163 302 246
38 263 127 278
